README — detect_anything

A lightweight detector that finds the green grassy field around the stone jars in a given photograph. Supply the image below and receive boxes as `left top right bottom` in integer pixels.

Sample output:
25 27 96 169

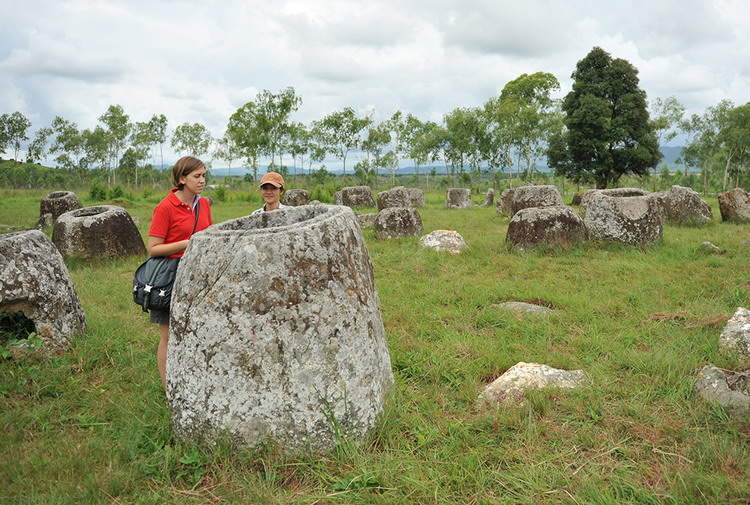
0 187 750 505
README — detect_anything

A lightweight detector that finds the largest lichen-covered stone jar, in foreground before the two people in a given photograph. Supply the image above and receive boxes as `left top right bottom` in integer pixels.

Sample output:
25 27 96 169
167 205 393 452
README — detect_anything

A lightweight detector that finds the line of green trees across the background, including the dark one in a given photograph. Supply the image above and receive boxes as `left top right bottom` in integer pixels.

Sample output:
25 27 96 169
0 47 750 190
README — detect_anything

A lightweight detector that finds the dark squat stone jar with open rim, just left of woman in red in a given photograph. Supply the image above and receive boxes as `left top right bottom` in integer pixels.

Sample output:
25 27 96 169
52 205 146 258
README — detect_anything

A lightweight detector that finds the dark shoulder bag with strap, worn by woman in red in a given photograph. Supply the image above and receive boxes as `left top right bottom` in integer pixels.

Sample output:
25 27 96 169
133 197 201 312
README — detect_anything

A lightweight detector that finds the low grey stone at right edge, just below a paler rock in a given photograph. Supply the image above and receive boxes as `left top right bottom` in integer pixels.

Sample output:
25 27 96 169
695 365 750 417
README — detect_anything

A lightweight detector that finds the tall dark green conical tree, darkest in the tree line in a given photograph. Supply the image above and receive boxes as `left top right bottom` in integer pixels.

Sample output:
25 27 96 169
547 47 661 188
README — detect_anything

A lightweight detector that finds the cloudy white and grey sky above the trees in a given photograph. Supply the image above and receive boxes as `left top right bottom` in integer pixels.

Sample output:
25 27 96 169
0 0 750 161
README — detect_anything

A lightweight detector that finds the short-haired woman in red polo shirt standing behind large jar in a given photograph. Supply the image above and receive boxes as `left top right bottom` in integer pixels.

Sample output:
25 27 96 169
148 156 211 389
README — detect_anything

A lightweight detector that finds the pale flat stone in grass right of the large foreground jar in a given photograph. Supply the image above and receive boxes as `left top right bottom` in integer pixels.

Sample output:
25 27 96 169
479 362 588 405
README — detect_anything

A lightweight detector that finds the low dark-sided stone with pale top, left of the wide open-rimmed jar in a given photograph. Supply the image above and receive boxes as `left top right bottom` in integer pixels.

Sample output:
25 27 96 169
505 205 587 249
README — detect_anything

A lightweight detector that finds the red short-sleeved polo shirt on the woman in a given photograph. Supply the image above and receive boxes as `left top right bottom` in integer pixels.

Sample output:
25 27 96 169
148 189 211 258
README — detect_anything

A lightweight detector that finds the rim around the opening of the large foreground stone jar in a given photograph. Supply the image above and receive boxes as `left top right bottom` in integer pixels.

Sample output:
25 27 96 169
196 204 356 236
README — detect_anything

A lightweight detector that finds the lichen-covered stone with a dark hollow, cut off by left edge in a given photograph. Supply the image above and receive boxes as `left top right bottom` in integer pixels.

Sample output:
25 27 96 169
0 230 86 352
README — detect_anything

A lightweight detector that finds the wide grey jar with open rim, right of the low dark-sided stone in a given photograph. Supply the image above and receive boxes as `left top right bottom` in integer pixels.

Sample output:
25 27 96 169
584 193 663 245
